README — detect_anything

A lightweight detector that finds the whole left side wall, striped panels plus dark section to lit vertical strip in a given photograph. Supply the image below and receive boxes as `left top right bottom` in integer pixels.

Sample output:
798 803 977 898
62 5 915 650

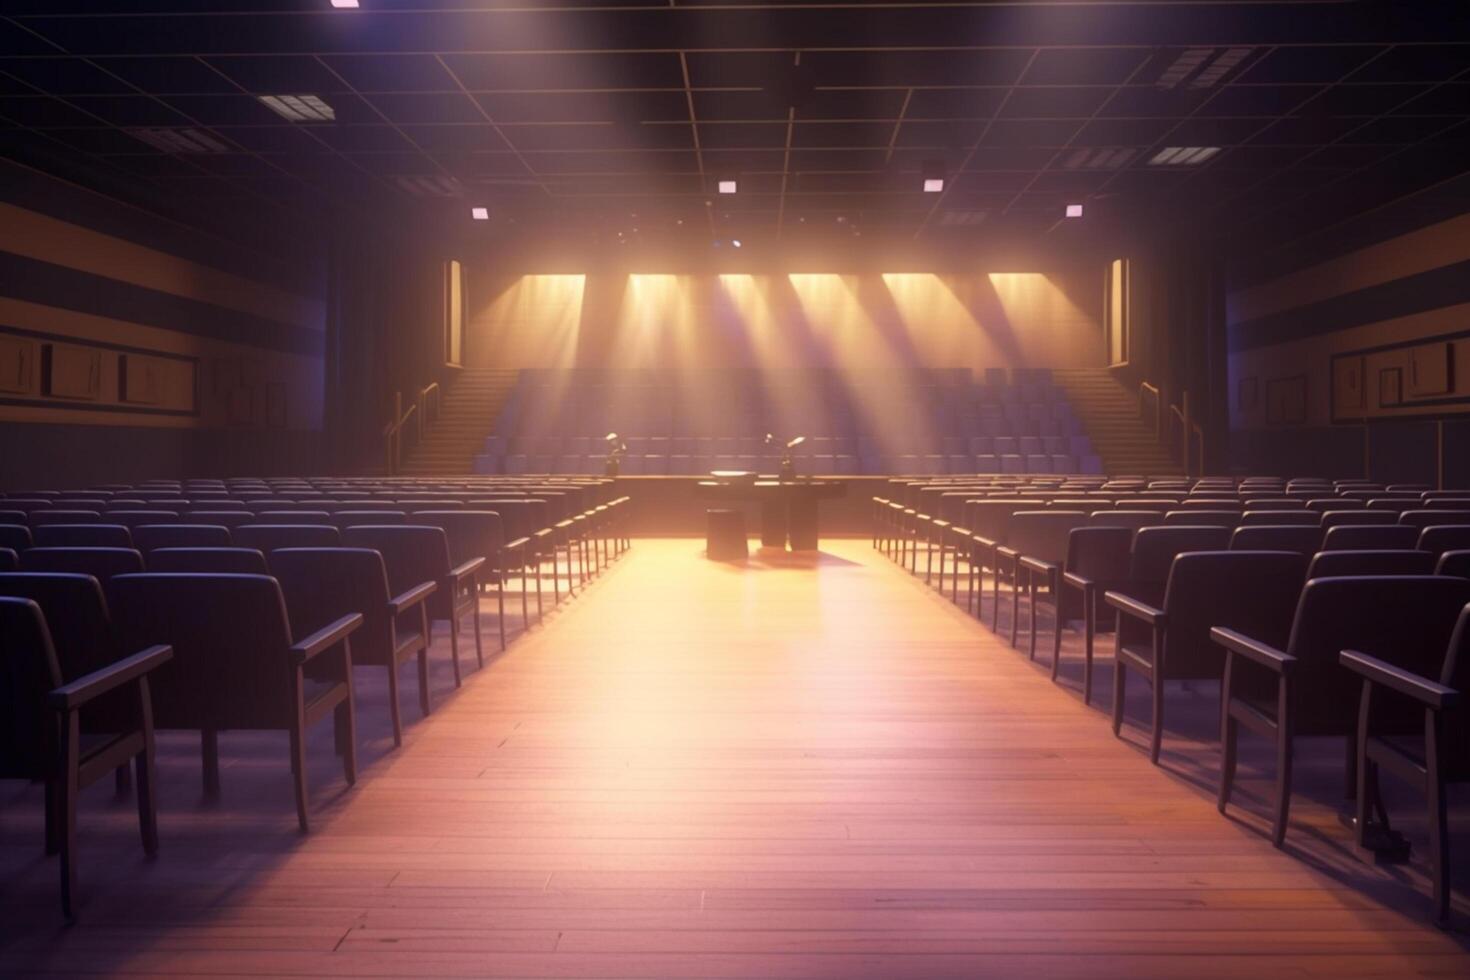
0 159 453 489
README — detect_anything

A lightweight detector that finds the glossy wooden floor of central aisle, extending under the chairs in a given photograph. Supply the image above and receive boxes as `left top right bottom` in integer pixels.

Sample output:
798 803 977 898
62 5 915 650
0 539 1470 979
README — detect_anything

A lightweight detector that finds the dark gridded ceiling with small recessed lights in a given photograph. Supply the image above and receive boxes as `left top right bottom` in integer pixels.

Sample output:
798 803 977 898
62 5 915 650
0 0 1470 262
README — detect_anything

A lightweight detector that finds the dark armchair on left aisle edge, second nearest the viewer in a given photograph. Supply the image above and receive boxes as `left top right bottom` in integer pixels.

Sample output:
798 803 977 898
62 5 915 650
112 573 363 832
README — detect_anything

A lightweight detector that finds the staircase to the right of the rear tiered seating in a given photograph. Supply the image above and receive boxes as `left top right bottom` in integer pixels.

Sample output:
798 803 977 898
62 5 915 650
1051 367 1185 476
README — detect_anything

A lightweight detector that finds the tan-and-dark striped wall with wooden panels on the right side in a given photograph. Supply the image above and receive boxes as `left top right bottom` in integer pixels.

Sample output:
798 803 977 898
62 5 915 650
1227 175 1470 486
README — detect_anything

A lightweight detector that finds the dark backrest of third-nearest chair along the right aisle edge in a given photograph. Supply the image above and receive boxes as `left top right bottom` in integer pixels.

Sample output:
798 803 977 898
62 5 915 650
1155 551 1307 683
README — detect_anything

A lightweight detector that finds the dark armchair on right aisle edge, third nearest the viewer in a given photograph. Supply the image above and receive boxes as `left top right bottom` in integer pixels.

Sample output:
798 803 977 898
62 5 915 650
1105 551 1307 765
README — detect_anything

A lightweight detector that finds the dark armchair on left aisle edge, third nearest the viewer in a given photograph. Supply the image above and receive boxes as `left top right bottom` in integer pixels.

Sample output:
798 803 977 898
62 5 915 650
270 548 437 745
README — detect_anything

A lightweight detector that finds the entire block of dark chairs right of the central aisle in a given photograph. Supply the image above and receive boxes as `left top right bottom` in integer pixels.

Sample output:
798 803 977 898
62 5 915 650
873 480 1470 921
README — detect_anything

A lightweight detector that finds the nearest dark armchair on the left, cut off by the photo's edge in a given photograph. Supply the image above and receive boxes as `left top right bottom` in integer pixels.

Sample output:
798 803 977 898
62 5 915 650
0 598 172 920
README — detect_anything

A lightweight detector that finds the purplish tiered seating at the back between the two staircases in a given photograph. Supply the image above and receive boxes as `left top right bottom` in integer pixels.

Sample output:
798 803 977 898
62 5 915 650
475 369 1103 476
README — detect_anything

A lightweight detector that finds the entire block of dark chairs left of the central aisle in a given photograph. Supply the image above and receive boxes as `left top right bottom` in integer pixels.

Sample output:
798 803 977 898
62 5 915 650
0 478 629 915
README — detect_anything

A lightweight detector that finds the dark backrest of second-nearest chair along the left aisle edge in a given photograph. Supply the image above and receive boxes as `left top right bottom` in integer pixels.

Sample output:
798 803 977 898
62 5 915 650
112 573 294 729
